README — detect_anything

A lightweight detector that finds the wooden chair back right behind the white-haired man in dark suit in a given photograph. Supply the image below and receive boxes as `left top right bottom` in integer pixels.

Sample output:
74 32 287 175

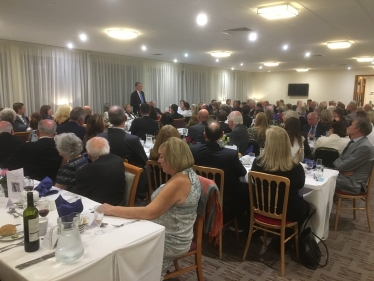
123 162 143 207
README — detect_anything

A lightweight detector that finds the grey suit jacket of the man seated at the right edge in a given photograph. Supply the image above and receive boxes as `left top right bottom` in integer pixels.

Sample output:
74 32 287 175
334 137 374 194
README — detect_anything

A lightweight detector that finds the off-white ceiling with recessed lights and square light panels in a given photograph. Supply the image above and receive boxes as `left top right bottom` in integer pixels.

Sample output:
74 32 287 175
0 0 374 72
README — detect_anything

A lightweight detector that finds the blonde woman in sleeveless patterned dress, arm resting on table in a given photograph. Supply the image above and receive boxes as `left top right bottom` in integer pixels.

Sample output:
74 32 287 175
103 137 201 280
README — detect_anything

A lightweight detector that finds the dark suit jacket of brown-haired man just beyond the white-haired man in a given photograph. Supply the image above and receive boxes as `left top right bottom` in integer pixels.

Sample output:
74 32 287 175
98 128 148 168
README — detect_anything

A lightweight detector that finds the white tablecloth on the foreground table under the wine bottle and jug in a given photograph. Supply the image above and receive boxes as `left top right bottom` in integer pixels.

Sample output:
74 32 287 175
0 188 165 281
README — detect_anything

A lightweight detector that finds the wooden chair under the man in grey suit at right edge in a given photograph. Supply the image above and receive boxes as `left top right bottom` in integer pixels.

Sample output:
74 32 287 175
334 163 374 232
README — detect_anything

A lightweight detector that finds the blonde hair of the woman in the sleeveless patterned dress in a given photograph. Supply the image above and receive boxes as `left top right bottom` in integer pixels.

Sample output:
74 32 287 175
158 137 195 172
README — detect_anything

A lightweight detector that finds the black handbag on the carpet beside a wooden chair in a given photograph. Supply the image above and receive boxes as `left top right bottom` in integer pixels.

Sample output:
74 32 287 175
299 210 329 270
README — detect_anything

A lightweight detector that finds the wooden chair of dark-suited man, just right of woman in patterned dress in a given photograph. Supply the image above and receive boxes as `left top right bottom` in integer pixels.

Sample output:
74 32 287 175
192 165 239 259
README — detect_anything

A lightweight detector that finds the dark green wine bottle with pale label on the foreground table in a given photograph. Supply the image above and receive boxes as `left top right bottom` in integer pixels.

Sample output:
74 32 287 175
23 192 40 252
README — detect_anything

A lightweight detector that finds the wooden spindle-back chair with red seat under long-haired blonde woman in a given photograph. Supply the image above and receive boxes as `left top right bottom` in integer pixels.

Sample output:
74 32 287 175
243 171 299 276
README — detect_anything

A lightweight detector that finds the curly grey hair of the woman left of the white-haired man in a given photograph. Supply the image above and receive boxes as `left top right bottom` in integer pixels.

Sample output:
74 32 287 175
55 133 83 160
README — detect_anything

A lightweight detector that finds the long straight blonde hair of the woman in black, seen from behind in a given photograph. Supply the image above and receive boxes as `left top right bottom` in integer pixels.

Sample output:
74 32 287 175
257 126 297 172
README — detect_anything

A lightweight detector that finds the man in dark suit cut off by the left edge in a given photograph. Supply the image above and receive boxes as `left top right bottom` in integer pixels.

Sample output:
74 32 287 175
0 121 26 164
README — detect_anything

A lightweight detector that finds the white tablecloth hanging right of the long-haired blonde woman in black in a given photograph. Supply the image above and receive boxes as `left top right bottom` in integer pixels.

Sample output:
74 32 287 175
240 161 339 240
